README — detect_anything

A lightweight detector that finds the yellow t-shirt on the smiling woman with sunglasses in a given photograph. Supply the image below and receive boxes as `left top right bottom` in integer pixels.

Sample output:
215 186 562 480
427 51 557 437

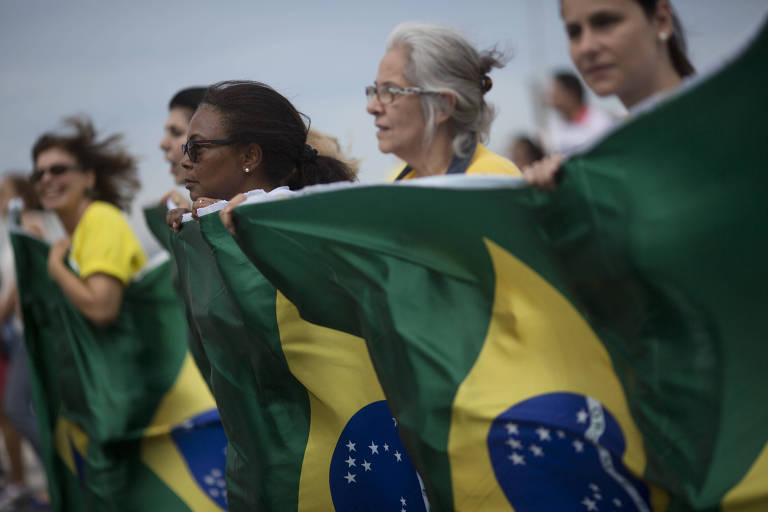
71 201 147 284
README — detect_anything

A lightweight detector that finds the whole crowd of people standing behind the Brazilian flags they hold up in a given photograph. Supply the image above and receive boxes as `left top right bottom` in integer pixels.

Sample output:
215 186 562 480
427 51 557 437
0 0 694 511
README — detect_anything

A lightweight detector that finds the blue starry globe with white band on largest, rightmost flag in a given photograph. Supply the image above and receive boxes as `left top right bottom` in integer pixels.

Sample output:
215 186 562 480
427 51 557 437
488 393 652 512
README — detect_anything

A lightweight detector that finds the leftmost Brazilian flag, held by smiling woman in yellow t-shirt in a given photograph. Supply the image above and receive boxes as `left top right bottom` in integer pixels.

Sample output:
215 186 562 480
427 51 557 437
11 225 227 512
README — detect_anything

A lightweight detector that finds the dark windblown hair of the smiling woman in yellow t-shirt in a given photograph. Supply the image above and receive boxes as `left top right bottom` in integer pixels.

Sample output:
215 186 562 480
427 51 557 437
32 117 141 211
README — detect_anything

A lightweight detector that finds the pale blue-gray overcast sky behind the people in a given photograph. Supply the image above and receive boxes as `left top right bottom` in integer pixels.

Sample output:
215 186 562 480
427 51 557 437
0 0 768 252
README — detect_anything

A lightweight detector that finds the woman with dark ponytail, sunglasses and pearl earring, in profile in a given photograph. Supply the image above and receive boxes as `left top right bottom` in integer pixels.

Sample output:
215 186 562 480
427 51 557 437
168 81 355 231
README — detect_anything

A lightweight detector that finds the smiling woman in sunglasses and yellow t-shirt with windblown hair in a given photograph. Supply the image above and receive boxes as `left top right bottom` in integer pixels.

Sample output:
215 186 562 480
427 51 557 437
31 118 146 326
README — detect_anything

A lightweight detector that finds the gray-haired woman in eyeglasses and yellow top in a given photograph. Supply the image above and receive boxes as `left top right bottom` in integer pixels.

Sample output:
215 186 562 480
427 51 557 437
365 23 520 181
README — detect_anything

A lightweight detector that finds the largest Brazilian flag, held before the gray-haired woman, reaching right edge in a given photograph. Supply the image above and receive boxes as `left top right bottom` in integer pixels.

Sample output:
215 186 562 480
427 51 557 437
222 20 768 512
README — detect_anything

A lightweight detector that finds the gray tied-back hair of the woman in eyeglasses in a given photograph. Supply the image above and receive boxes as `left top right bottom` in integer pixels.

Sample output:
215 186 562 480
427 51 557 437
387 23 505 157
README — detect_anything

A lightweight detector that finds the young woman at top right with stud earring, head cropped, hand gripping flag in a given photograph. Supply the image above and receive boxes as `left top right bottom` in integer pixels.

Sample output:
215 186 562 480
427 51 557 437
524 0 695 190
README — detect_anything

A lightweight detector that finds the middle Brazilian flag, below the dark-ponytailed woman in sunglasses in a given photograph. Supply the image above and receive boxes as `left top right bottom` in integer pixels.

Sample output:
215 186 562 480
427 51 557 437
166 213 426 512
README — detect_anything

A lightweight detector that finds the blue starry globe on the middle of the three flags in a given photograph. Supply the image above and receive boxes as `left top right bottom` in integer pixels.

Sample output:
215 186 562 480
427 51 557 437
329 400 426 512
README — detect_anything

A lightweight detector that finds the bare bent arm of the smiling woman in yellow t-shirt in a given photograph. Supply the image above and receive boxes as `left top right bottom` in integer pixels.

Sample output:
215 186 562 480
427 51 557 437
48 239 123 327
